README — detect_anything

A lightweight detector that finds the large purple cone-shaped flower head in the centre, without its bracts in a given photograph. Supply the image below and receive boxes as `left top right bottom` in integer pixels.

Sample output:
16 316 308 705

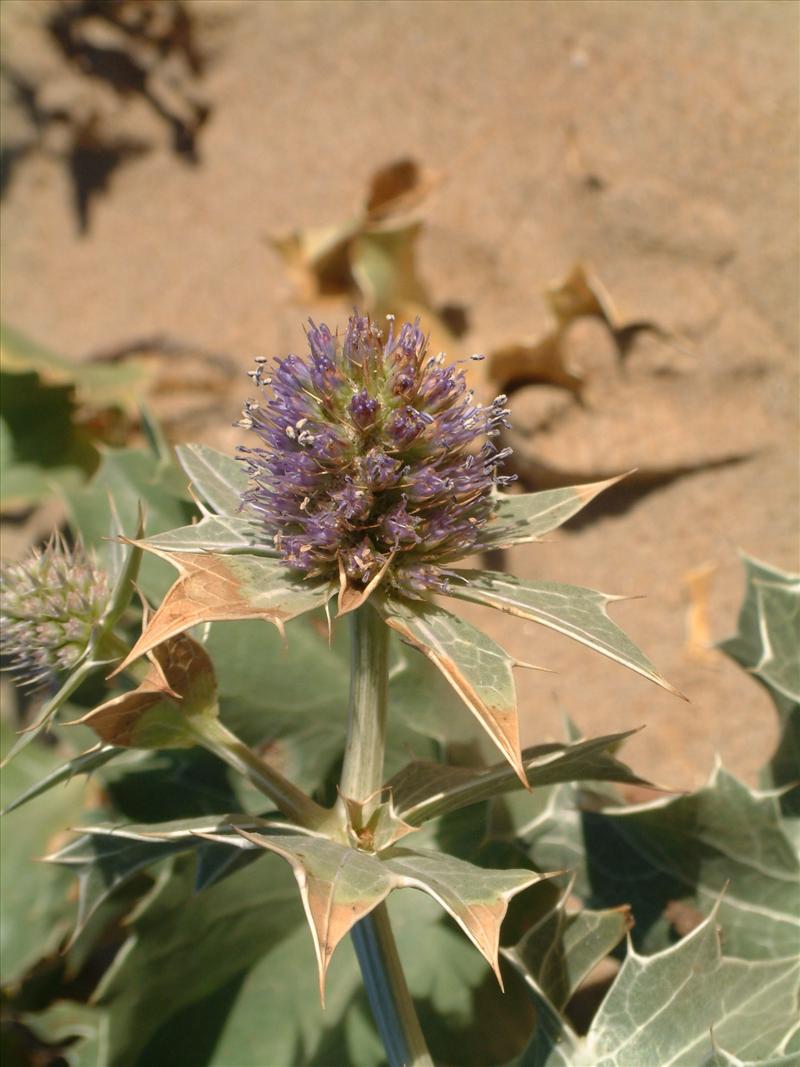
239 315 511 596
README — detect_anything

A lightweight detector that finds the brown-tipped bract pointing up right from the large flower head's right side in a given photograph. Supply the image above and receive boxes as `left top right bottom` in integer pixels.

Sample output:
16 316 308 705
480 474 627 548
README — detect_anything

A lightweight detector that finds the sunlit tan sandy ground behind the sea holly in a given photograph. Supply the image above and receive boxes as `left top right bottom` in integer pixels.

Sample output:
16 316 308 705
0 0 800 786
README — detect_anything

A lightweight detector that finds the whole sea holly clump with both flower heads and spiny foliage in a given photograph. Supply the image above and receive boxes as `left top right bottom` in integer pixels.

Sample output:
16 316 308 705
15 317 800 1067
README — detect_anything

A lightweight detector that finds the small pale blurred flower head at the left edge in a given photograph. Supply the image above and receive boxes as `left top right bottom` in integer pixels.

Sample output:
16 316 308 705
0 536 110 685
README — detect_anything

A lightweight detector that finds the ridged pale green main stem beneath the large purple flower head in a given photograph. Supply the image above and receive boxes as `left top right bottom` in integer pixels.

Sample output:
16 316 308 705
339 604 433 1067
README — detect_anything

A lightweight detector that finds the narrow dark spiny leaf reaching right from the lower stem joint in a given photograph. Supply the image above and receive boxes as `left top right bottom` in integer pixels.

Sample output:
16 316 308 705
386 730 651 826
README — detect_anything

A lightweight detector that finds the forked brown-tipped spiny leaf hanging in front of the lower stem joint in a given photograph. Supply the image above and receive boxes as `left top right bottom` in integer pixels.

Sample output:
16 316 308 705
233 831 549 993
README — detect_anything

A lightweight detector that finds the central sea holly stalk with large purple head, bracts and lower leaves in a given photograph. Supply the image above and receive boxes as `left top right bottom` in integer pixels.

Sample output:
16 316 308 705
1 316 691 1065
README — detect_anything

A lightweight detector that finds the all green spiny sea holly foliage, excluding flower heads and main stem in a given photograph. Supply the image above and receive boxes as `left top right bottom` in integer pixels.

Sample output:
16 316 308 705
2 420 800 1067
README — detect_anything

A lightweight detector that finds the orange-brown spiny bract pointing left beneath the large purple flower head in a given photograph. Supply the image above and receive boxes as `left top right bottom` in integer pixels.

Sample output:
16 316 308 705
117 541 332 671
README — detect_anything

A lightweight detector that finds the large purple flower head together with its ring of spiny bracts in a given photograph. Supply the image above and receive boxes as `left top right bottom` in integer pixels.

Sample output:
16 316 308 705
114 316 669 789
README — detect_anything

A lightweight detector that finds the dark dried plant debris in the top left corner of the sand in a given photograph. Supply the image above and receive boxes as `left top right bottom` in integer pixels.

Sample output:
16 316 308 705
2 0 210 234
